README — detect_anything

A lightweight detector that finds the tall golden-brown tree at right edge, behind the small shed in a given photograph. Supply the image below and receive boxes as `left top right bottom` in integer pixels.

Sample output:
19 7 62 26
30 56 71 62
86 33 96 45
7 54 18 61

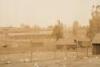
87 5 100 40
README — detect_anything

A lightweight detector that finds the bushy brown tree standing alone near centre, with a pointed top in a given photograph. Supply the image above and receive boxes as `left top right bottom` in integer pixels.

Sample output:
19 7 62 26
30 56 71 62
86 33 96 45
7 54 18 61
52 20 63 40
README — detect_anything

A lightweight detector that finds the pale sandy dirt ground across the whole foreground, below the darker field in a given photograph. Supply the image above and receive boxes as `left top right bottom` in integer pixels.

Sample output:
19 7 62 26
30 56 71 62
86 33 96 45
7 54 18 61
0 52 100 67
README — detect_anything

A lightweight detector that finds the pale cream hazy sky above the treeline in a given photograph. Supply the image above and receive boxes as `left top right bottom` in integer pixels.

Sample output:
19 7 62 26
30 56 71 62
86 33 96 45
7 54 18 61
0 0 100 26
